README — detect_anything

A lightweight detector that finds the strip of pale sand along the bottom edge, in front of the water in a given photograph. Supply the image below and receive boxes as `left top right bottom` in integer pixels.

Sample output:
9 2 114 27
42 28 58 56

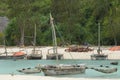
0 75 119 80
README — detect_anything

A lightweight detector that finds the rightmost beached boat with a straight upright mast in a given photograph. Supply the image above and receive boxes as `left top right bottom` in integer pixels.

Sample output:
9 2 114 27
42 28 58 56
91 23 108 60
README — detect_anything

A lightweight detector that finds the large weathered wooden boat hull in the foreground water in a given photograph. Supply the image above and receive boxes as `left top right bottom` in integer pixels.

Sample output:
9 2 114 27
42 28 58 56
40 64 86 76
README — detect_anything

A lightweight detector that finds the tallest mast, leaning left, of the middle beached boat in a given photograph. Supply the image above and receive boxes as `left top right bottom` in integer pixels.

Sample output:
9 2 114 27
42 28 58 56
50 13 58 60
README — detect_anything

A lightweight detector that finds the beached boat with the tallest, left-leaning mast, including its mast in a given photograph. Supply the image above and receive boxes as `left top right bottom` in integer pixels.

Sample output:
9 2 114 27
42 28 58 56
46 14 63 60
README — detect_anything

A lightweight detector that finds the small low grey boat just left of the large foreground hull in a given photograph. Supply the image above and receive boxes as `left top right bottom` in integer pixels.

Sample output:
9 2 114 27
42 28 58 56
17 68 41 74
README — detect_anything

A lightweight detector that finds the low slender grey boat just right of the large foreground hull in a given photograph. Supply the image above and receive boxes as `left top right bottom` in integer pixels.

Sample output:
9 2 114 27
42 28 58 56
91 65 117 73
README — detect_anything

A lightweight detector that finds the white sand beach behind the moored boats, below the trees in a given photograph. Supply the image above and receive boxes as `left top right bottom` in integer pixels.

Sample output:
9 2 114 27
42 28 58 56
0 46 120 60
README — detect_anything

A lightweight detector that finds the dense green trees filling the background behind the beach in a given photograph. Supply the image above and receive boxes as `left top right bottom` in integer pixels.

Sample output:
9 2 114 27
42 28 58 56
0 0 120 45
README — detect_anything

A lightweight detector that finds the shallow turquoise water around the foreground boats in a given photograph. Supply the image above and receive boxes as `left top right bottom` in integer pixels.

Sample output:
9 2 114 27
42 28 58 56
0 59 120 79
